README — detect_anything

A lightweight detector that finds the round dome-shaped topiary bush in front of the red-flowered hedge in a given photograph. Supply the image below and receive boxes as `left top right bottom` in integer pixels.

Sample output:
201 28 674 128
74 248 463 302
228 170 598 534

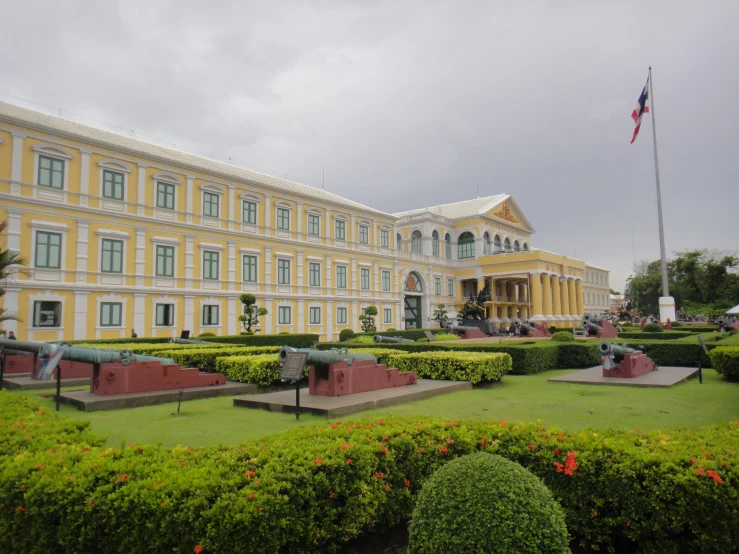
408 452 570 554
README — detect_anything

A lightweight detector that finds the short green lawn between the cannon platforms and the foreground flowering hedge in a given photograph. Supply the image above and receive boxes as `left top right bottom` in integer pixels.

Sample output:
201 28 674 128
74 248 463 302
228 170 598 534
7 369 739 446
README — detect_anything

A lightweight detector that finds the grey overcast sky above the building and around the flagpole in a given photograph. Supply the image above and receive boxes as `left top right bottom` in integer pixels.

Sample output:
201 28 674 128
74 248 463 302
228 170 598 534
0 0 739 290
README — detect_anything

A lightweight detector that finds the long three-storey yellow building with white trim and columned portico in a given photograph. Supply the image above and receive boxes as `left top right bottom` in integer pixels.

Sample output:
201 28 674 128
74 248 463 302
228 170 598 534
0 102 607 340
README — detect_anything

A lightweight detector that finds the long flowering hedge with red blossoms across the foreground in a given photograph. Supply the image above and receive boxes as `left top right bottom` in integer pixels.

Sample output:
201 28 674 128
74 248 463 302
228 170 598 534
0 393 739 554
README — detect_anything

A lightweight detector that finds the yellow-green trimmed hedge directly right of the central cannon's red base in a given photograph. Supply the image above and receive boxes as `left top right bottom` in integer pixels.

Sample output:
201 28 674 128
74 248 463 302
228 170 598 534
388 352 511 385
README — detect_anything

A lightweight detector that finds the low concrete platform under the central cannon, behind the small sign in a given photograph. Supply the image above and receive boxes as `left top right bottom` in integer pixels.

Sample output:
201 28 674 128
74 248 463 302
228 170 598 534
233 379 472 417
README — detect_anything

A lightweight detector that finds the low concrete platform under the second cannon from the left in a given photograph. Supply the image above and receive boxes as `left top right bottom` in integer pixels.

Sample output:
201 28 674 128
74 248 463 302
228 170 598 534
60 379 256 412
